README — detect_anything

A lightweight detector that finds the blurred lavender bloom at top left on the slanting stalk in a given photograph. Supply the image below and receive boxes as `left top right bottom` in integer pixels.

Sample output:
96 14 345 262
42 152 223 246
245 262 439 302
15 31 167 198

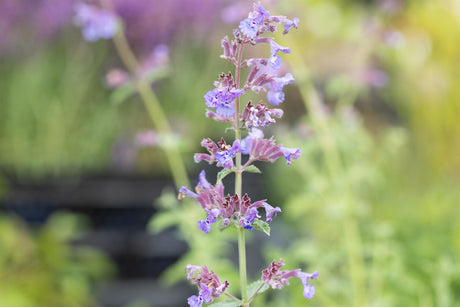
75 3 118 42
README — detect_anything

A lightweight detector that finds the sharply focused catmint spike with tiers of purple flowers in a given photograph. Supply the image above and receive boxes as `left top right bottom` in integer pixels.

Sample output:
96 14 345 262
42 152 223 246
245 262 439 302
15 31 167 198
179 5 318 307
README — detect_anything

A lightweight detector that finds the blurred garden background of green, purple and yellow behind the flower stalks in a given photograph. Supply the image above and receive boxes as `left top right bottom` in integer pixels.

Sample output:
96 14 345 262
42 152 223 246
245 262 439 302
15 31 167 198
0 0 460 307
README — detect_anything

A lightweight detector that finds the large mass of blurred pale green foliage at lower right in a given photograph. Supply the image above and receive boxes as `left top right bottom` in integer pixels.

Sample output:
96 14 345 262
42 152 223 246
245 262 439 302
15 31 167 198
267 103 460 306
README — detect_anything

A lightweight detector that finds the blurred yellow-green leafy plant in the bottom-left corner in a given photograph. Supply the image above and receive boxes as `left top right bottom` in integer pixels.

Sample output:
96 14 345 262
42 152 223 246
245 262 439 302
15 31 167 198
0 213 113 307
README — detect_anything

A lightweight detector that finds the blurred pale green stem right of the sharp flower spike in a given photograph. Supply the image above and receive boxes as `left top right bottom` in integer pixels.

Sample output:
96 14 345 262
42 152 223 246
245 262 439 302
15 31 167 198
291 51 367 307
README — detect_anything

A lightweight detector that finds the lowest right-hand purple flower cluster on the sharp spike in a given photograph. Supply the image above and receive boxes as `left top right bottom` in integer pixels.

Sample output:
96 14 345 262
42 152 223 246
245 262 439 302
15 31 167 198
262 260 319 299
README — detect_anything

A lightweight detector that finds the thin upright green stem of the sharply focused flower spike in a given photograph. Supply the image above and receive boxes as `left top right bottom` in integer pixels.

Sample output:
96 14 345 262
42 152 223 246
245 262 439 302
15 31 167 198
235 44 249 307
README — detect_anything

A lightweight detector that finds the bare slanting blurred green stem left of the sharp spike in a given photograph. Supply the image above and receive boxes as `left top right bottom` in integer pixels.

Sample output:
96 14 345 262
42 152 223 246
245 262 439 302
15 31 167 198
101 0 189 187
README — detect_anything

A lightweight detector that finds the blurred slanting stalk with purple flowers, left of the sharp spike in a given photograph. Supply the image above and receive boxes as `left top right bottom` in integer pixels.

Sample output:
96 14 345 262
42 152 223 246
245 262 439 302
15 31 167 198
74 0 188 187
